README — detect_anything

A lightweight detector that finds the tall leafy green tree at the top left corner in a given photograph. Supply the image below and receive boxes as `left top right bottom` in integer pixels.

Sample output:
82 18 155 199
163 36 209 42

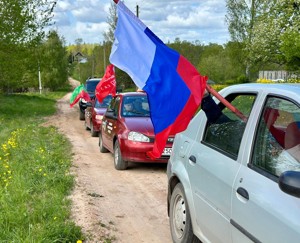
0 0 56 91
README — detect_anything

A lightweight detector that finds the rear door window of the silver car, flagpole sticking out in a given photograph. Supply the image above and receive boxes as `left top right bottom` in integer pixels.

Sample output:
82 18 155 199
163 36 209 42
203 94 256 158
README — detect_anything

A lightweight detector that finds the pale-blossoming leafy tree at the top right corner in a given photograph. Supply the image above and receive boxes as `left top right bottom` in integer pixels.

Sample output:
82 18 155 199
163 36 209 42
249 0 300 69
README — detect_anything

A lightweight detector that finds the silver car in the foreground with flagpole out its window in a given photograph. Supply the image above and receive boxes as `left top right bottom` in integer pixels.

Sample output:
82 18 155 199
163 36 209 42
167 84 300 243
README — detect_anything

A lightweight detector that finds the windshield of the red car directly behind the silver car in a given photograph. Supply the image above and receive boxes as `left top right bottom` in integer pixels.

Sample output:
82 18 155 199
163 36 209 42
122 95 150 117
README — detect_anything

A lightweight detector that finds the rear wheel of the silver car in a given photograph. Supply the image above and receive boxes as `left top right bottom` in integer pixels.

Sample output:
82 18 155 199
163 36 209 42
169 183 197 243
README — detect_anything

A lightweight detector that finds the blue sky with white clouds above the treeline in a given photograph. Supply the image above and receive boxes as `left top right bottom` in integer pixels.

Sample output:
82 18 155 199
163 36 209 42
51 0 230 45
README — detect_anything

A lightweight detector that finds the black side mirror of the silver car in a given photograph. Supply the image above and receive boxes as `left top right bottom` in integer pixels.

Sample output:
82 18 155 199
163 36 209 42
278 171 300 198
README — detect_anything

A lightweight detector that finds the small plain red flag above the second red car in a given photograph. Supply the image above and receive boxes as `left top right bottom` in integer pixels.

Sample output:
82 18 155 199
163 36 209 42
95 64 116 103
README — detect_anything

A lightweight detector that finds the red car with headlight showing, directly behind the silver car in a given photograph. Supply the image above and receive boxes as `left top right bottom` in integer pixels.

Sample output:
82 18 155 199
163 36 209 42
99 92 174 170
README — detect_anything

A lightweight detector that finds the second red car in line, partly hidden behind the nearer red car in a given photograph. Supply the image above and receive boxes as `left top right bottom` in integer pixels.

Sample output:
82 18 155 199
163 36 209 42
85 95 112 137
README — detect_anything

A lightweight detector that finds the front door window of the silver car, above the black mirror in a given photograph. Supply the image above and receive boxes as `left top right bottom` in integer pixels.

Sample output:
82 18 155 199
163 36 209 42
252 97 300 177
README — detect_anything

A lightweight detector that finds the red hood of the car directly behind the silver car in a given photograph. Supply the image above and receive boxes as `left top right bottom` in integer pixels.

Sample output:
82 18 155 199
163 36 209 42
124 117 154 137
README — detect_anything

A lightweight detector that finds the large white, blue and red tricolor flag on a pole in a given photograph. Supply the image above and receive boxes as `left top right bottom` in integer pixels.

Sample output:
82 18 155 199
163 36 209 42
110 1 207 158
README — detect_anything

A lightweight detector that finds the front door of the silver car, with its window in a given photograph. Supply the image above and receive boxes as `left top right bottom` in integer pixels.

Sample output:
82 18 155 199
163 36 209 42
231 95 300 243
